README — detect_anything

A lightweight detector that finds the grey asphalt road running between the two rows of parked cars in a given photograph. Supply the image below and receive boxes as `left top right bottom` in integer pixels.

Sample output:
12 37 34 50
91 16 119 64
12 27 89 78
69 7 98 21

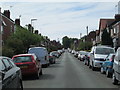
23 52 119 88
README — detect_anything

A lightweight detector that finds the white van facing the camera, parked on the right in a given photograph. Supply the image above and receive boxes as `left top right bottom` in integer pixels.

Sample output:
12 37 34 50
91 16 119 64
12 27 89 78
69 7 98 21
89 46 115 70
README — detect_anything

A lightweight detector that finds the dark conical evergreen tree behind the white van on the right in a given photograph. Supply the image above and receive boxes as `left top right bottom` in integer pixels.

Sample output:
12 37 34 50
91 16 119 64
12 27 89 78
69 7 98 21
101 29 113 46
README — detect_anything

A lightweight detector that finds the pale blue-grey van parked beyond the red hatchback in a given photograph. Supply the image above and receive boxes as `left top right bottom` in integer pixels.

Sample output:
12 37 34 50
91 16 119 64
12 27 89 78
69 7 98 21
28 47 49 67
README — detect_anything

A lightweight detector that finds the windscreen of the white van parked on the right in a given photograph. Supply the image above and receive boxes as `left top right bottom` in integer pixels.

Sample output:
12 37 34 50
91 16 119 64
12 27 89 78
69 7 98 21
95 48 114 55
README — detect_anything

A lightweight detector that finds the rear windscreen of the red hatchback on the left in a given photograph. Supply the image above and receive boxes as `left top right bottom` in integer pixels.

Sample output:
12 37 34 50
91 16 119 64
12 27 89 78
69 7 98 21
13 56 32 63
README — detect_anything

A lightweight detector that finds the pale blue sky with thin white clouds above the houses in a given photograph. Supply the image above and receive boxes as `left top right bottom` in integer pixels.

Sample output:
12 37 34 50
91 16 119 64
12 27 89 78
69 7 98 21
0 0 118 41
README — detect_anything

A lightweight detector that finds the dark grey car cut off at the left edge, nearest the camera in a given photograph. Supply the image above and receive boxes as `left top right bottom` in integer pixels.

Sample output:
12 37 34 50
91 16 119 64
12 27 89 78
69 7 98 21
0 56 23 90
